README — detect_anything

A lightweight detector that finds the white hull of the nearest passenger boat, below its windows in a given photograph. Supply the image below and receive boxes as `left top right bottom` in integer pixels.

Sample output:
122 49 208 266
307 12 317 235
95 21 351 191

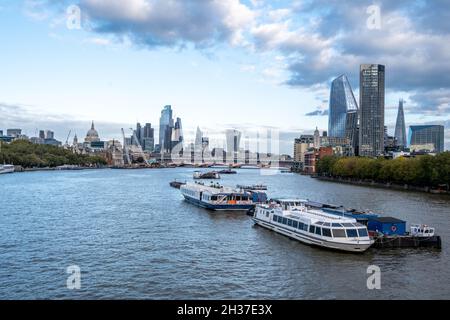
253 217 372 253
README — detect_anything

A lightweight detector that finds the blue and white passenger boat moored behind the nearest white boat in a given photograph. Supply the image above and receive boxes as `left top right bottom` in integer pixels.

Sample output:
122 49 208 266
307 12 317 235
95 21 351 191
180 182 267 211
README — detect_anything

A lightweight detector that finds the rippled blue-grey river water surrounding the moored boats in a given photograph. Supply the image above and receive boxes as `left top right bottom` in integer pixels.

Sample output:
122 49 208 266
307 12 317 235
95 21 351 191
0 168 450 299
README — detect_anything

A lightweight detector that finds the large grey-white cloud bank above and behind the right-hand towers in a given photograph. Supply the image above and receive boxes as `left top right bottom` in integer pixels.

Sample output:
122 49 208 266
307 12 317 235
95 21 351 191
252 0 450 114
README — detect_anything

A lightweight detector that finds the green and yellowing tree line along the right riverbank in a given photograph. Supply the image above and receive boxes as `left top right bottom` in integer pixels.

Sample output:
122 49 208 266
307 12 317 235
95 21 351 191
316 151 450 187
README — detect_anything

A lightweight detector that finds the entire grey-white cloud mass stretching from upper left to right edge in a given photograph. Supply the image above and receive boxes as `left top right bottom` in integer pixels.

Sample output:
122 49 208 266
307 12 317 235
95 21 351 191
27 0 450 116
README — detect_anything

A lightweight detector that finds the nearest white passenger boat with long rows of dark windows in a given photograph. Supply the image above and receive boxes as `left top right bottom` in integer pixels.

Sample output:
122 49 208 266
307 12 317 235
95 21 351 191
253 199 374 252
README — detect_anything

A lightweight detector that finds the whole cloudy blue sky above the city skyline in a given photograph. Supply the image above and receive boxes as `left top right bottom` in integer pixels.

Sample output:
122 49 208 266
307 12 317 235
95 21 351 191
0 0 450 154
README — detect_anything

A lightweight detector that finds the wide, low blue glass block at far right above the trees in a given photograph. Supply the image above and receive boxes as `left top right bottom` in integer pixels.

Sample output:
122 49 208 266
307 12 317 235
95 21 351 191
408 125 444 153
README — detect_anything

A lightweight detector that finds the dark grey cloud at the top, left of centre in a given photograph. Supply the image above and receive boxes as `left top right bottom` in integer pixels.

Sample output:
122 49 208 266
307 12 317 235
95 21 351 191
75 0 254 48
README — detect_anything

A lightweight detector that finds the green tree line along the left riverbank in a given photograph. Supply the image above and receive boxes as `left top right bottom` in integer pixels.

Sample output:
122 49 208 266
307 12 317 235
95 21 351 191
0 140 106 168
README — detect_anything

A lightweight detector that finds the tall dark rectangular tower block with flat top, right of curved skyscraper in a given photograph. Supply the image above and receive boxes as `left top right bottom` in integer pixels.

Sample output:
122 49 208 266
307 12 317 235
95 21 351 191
359 64 385 157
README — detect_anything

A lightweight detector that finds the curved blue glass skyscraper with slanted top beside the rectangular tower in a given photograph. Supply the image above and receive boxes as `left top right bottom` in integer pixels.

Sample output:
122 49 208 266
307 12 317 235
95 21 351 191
328 75 358 138
